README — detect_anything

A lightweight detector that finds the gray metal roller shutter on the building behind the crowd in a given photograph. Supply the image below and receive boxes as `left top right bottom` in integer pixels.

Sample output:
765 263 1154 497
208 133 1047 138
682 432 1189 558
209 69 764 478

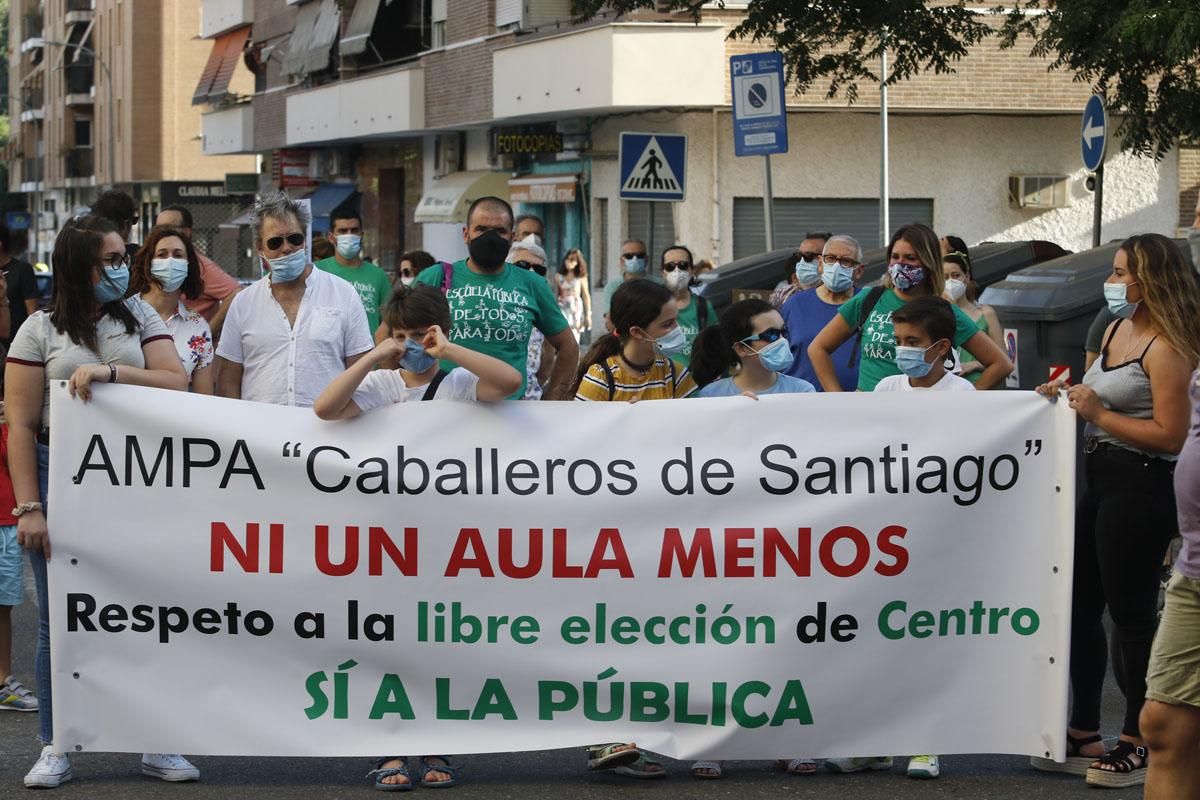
733 197 934 259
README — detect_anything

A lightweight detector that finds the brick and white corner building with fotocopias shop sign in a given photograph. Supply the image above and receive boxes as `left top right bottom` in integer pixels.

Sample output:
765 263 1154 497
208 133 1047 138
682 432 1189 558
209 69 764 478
194 0 1200 286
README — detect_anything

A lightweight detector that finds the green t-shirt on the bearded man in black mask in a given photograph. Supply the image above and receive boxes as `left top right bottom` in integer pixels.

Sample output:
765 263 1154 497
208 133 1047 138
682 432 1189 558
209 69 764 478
416 260 566 399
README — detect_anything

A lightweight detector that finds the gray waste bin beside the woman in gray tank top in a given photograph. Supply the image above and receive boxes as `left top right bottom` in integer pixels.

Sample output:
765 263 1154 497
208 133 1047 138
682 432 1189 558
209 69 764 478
979 243 1117 389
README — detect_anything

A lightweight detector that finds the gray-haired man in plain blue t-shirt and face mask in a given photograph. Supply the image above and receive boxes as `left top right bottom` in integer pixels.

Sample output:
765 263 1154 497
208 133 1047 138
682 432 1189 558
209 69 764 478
779 235 863 391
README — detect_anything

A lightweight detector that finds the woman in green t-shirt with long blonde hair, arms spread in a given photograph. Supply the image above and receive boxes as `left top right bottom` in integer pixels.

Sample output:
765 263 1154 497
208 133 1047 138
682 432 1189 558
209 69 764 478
808 222 1013 392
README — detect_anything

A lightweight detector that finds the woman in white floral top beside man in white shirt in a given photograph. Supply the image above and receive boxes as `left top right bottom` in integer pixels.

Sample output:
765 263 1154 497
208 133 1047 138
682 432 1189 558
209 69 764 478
130 225 215 395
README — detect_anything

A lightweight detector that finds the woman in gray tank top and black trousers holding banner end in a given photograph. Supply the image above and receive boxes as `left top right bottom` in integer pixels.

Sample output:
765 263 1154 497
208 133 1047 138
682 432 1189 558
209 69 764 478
1033 234 1200 787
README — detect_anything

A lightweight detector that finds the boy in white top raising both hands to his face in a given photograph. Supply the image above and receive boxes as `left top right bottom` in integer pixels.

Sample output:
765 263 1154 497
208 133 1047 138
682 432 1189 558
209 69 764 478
312 284 522 420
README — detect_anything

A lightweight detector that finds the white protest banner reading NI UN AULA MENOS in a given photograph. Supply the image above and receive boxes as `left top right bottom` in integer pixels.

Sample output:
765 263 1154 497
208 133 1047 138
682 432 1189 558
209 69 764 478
49 384 1074 758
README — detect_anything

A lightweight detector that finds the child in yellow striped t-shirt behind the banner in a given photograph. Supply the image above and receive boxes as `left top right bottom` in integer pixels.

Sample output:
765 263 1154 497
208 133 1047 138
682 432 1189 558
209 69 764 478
575 279 696 402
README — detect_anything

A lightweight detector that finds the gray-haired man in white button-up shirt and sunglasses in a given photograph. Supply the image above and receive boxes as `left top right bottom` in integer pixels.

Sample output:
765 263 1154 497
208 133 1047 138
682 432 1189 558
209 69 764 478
217 192 374 407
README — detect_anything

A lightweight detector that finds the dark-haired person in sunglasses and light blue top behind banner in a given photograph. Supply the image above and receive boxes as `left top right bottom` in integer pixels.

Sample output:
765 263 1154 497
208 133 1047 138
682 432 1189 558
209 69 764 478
691 300 816 397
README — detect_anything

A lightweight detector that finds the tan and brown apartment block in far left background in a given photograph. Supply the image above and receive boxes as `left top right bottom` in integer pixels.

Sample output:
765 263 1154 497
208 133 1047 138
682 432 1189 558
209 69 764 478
8 0 257 268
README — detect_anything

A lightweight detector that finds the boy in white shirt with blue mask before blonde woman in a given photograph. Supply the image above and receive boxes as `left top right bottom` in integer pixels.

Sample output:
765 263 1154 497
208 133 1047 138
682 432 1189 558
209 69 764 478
875 297 974 392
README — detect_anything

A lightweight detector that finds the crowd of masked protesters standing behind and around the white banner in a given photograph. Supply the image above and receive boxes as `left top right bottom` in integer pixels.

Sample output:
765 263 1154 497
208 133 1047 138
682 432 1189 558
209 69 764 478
0 193 1200 799
